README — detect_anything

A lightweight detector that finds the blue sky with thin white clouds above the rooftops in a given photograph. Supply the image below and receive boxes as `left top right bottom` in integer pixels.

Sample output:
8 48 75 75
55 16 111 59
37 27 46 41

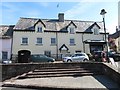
0 0 119 34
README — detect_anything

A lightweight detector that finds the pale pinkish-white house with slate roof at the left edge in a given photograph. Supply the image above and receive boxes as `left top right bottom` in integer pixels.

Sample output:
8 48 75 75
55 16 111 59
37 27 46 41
0 25 14 62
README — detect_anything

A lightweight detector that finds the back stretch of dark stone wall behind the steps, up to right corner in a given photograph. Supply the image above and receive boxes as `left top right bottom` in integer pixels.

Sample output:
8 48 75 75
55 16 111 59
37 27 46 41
1 62 102 81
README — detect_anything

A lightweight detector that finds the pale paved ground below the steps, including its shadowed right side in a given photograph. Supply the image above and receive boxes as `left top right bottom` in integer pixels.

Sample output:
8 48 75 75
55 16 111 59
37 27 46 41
3 75 120 90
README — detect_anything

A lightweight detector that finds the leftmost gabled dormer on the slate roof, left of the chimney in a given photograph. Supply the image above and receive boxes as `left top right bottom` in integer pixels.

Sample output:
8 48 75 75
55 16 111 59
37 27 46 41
34 19 46 33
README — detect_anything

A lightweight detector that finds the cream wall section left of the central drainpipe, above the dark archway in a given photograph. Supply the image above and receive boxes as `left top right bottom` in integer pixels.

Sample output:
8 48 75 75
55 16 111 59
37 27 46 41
13 31 56 54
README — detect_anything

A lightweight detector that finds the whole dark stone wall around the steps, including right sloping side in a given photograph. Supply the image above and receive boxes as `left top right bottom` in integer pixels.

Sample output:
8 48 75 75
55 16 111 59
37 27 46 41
0 62 120 85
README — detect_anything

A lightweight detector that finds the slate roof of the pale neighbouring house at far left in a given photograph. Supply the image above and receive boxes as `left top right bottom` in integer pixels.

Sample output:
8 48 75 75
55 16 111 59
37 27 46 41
0 25 15 38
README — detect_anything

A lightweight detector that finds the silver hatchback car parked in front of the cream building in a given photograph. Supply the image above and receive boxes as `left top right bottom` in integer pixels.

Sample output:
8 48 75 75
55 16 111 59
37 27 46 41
63 53 89 62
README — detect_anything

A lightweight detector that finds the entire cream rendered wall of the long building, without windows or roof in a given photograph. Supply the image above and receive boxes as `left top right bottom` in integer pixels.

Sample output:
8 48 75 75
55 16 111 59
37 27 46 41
12 31 103 54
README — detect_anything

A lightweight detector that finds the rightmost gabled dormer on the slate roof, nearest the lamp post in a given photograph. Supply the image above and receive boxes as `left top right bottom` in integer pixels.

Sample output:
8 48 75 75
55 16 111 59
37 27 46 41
85 22 100 35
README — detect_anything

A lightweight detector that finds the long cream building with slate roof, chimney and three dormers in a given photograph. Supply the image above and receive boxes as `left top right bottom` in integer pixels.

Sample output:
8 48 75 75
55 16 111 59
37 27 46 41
12 13 105 61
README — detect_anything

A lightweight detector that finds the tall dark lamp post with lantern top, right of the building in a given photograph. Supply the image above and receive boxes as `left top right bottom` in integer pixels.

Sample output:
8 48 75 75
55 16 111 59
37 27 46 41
100 9 108 58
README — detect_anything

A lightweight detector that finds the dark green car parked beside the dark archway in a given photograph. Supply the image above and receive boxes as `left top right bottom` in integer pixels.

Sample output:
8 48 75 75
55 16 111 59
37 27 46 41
31 54 55 62
